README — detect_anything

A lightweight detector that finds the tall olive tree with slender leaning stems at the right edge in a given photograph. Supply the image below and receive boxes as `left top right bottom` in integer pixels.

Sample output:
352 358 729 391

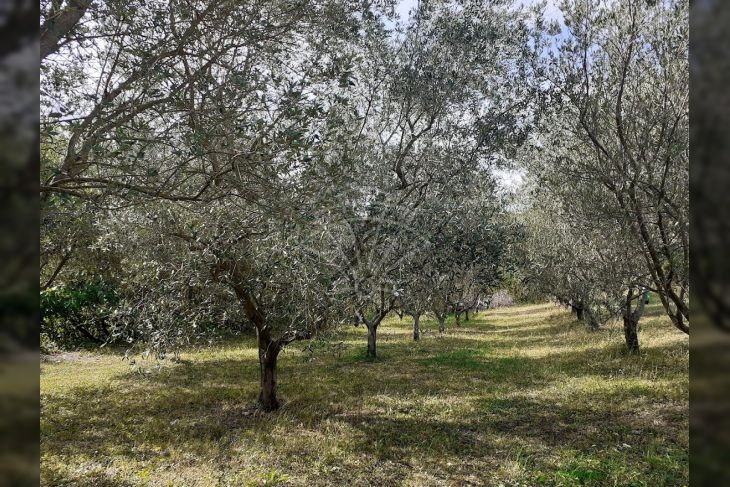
543 0 689 333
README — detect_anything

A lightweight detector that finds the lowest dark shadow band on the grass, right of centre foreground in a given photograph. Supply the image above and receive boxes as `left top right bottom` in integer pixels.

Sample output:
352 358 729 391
334 397 672 460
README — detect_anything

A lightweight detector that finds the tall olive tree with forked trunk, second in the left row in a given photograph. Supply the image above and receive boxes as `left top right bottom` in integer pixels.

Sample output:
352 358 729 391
316 2 533 357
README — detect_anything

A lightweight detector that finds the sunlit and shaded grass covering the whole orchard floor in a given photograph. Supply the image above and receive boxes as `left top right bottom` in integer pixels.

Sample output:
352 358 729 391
41 304 689 487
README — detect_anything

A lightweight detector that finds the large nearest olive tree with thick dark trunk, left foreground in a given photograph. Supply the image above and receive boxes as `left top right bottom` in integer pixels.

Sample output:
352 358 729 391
41 2 375 410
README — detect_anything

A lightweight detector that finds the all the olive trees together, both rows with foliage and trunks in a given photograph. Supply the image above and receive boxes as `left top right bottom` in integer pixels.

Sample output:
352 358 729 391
40 0 689 410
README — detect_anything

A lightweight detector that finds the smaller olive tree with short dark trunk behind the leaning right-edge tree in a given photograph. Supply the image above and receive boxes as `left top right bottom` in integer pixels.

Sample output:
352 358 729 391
521 184 649 353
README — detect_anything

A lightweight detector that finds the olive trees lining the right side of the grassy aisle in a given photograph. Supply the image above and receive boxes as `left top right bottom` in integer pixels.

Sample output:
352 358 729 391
524 0 689 352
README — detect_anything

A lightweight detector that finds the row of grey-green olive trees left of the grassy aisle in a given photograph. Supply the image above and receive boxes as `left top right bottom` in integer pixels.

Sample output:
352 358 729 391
41 0 540 410
